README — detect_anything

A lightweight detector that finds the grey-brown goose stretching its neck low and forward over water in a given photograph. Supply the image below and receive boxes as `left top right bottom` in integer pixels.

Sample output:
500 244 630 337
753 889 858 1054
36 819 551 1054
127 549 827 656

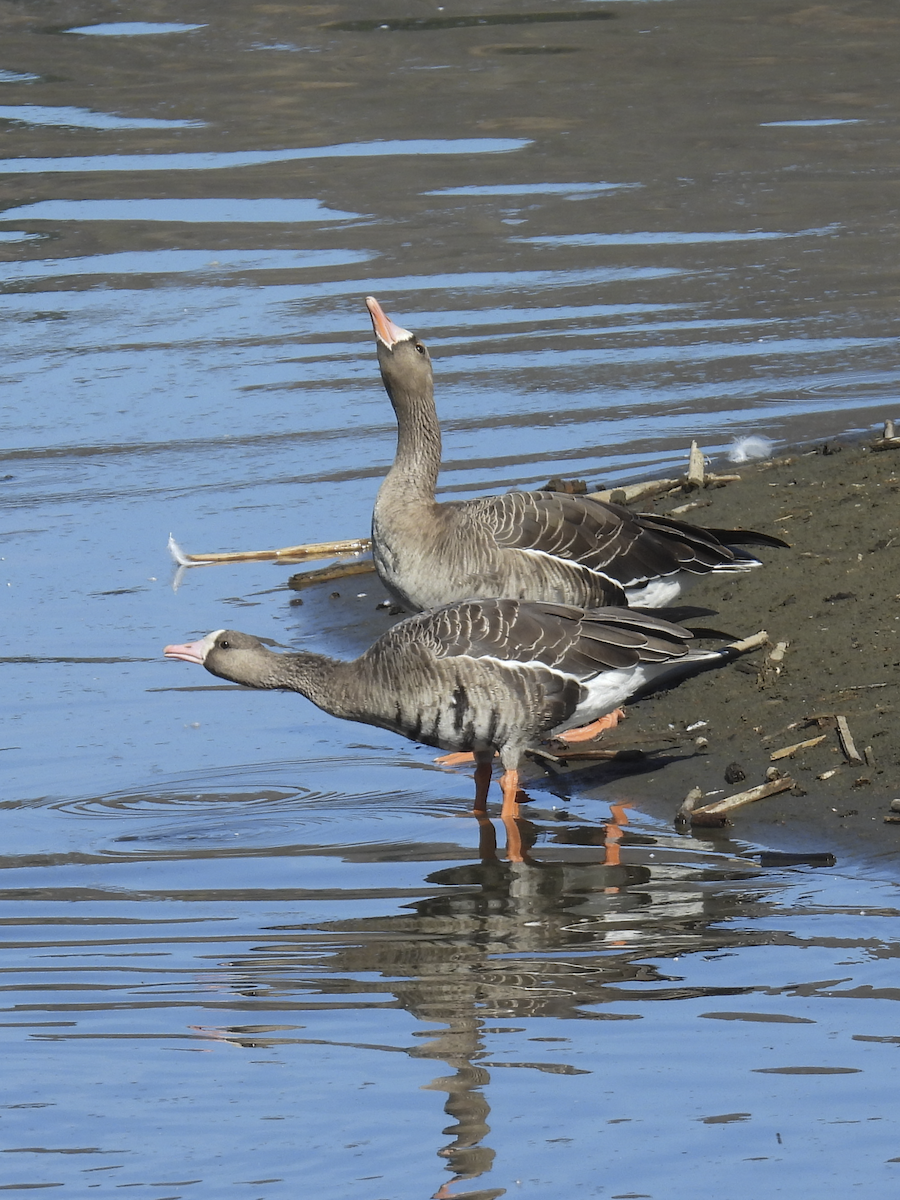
163 599 734 818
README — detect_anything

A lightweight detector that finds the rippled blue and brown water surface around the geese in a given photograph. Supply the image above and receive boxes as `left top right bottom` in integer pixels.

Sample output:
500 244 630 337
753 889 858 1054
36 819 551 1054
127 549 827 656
0 0 900 1200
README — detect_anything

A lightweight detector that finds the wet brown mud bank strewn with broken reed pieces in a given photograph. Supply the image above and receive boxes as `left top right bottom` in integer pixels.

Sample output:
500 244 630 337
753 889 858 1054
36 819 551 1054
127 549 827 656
535 443 900 868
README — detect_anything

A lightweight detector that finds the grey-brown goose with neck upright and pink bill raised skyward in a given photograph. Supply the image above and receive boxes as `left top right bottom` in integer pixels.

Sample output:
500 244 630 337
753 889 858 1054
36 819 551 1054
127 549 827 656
366 296 787 610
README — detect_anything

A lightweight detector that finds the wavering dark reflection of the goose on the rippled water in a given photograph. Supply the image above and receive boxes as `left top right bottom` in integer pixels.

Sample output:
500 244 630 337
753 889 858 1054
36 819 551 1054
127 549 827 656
180 802 758 1200
